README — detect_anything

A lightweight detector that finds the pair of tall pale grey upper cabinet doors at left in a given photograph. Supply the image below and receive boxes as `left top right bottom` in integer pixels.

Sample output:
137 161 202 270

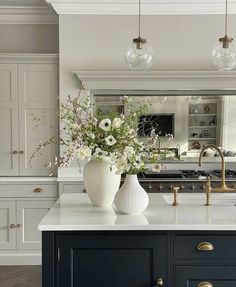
0 63 58 176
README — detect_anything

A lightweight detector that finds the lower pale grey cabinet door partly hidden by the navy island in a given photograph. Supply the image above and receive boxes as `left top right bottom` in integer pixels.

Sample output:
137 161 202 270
16 200 55 249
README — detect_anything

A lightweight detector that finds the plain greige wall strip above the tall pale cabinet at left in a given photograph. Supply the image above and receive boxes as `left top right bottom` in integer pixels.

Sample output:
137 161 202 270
0 24 59 53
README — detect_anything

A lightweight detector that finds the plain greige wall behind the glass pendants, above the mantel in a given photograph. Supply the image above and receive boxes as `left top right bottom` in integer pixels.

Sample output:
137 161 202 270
59 15 236 96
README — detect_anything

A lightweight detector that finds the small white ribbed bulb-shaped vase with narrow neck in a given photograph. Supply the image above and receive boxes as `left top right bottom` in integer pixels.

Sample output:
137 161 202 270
114 174 149 214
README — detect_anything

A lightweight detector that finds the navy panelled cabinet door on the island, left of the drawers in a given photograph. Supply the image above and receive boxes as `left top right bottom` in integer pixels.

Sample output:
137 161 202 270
56 232 168 287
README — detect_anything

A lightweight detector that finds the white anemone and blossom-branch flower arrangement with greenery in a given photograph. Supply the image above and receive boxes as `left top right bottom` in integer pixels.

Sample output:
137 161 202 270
32 89 164 174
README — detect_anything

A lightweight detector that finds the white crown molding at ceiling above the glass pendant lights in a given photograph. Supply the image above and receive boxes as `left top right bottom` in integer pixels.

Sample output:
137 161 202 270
46 0 236 15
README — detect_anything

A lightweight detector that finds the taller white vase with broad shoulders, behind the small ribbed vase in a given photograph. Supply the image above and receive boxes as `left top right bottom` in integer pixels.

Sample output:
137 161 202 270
84 159 121 206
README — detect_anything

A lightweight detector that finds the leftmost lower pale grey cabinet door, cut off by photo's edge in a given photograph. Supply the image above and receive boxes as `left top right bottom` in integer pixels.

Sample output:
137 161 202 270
0 201 16 249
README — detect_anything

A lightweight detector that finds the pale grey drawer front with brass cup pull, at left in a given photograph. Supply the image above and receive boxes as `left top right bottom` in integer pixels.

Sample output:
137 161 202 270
0 183 58 198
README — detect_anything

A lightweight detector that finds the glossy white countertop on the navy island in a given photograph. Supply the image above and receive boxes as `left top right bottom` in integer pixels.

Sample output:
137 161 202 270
39 194 236 231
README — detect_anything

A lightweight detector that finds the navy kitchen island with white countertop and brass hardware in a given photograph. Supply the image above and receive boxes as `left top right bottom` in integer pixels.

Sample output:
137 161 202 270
39 194 236 287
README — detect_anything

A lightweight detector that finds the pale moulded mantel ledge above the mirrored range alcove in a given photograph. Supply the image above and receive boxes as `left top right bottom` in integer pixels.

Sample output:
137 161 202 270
73 71 236 90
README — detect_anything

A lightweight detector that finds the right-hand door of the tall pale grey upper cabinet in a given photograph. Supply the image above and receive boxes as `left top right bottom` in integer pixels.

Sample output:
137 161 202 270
18 64 58 176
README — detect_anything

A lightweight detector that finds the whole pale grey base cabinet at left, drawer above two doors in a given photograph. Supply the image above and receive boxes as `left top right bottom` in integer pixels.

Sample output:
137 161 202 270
0 182 58 266
